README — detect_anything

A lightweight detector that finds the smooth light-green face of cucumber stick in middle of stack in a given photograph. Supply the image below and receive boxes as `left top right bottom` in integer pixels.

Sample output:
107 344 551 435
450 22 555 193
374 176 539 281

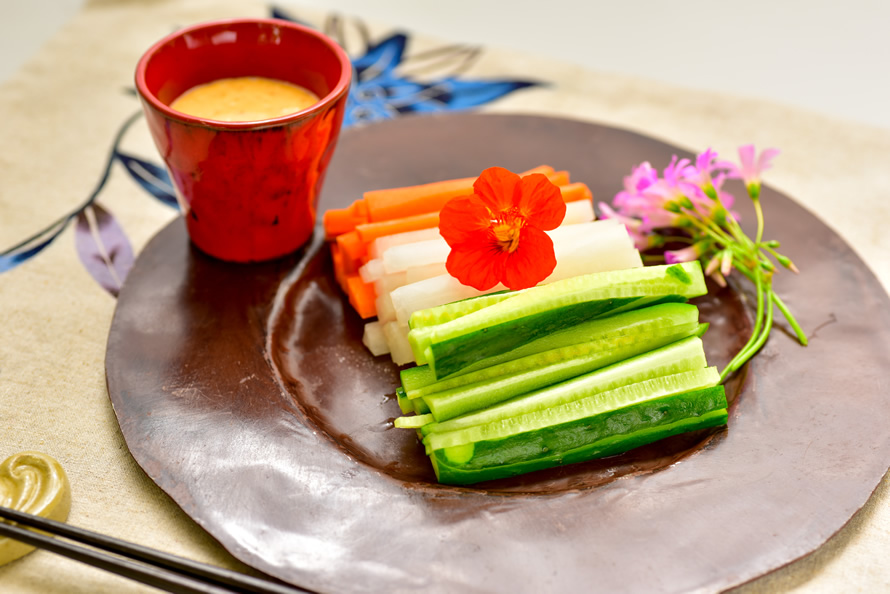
420 327 695 422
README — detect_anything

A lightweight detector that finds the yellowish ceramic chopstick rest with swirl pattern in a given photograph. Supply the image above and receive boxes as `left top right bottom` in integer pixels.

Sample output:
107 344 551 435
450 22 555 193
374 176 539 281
0 452 71 565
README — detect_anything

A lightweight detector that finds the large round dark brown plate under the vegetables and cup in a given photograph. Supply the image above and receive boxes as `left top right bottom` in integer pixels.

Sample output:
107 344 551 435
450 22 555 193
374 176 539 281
106 115 890 592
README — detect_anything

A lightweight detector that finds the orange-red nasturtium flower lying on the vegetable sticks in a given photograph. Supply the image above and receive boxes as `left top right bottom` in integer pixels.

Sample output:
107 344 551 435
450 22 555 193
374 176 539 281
439 167 566 291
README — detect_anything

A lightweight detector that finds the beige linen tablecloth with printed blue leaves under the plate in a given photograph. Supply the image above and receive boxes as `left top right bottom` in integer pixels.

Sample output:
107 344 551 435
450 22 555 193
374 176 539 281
0 0 890 593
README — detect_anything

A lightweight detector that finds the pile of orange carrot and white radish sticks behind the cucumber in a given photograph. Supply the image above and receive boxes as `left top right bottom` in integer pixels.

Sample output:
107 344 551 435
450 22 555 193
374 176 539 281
324 165 642 365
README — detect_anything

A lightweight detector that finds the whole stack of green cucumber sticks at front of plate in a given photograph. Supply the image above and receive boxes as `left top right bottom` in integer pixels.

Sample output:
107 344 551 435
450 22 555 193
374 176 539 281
394 261 727 484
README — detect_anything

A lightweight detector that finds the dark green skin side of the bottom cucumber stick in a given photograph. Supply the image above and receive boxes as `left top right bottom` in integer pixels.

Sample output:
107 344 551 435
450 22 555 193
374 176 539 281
430 386 728 485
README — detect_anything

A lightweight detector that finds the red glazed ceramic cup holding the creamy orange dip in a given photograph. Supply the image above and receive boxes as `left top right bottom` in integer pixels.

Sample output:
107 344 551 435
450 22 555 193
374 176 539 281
136 19 352 262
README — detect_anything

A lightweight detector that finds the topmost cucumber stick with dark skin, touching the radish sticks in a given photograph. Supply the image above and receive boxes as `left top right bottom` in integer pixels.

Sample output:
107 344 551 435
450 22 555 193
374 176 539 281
409 261 707 379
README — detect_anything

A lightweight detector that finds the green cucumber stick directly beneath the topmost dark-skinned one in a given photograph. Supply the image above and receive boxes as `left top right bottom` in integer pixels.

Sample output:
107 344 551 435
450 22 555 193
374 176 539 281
399 303 698 390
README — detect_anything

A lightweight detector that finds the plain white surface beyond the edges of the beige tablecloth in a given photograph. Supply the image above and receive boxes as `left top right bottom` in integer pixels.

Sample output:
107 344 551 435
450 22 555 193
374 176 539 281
0 0 890 129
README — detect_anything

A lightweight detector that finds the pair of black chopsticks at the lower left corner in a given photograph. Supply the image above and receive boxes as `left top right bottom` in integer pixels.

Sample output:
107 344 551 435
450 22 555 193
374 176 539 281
0 506 308 594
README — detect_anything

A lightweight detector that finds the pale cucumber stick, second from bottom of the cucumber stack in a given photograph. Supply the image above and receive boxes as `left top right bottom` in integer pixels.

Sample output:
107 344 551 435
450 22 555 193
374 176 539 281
422 337 717 435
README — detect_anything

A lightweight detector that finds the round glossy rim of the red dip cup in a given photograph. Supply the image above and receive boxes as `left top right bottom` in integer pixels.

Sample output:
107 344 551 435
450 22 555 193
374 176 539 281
136 18 352 131
